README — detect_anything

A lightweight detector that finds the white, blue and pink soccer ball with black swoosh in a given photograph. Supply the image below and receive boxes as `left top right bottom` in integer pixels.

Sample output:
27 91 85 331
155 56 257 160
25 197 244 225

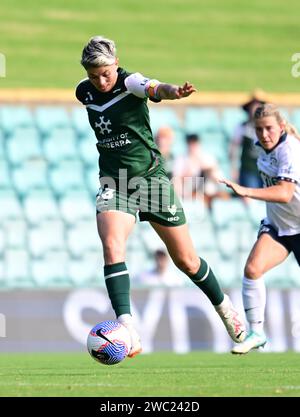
87 320 131 365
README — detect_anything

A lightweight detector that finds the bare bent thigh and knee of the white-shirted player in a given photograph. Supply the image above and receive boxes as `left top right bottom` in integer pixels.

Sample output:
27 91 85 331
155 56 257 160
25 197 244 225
245 233 289 276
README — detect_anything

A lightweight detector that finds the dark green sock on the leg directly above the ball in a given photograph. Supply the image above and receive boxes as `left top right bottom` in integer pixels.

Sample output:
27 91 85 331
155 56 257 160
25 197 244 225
104 262 131 317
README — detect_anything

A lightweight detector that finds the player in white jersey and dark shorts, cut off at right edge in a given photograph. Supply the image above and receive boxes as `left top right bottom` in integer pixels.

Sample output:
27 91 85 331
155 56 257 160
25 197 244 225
221 104 300 354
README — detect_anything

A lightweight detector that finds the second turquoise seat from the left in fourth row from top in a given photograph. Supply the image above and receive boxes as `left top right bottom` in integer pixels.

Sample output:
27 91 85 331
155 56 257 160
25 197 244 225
23 189 61 225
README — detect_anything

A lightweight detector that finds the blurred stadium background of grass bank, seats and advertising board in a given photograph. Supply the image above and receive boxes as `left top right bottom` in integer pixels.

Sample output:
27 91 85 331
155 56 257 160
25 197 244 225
0 0 300 352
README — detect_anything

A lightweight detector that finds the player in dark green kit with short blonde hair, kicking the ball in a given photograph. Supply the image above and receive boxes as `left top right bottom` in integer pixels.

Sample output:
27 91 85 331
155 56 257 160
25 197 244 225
76 36 246 357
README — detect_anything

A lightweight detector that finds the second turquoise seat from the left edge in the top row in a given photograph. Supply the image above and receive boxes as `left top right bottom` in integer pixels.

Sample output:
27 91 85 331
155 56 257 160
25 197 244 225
34 106 71 136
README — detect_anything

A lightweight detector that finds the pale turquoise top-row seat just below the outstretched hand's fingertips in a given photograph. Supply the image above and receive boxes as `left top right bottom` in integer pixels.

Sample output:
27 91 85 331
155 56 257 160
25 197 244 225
184 107 222 137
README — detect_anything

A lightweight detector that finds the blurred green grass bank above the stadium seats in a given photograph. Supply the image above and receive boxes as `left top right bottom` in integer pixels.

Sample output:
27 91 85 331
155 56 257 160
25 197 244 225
0 0 300 92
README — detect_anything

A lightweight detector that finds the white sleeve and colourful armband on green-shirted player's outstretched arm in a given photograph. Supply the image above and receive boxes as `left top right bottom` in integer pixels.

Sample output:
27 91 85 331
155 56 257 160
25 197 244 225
124 72 160 99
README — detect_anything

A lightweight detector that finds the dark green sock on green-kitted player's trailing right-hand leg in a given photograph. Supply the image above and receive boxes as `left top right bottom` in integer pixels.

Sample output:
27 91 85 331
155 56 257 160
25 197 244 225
190 258 224 306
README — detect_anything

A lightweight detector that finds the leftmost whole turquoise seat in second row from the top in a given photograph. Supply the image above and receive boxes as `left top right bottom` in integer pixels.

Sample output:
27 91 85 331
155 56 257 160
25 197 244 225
6 127 44 165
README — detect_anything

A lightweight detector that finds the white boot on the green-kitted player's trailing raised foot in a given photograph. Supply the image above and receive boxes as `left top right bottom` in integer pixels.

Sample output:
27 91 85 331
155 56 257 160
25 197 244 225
215 294 246 343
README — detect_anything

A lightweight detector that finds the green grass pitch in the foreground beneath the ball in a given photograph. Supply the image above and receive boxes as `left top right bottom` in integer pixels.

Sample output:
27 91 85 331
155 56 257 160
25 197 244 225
0 352 300 397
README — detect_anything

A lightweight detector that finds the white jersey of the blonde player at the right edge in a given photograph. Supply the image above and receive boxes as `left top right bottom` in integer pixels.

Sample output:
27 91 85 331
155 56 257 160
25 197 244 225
257 134 300 236
